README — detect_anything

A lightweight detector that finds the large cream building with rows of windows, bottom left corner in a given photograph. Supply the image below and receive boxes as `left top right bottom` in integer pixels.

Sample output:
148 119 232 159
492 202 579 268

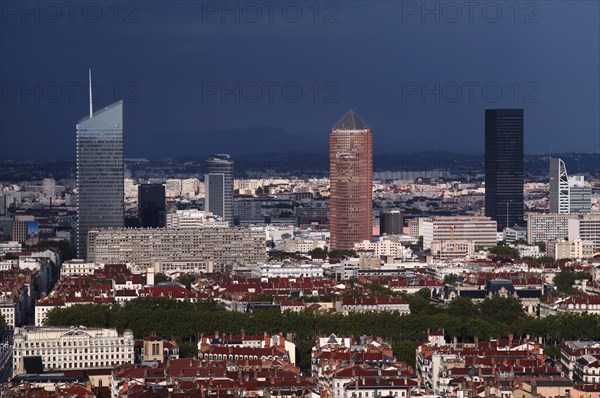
13 326 134 375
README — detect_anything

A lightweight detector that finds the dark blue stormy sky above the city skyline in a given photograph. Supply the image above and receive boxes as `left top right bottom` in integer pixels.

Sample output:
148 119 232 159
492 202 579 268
0 0 600 160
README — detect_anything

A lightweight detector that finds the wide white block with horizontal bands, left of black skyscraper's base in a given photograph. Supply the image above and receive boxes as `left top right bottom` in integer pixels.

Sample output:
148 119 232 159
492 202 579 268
422 216 497 250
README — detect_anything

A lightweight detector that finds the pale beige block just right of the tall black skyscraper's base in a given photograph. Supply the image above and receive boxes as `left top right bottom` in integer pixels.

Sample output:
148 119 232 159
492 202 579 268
527 213 579 245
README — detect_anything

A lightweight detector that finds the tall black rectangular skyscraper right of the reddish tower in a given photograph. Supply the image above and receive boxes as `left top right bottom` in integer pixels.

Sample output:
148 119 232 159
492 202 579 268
485 109 524 229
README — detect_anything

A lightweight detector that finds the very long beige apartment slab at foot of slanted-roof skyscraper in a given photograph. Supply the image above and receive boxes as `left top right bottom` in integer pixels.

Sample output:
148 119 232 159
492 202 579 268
88 227 267 272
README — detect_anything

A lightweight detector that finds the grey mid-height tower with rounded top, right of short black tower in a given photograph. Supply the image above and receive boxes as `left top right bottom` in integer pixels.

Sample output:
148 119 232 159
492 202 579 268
204 154 233 225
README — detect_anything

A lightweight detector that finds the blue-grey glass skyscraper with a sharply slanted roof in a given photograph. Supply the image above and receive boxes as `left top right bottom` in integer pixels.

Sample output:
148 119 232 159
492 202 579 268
77 101 125 258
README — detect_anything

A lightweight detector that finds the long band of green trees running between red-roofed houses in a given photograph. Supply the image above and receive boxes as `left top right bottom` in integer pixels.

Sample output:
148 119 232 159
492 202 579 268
46 288 600 371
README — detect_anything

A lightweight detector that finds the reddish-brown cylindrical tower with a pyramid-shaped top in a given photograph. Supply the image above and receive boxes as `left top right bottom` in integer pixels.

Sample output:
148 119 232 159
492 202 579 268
329 110 373 250
